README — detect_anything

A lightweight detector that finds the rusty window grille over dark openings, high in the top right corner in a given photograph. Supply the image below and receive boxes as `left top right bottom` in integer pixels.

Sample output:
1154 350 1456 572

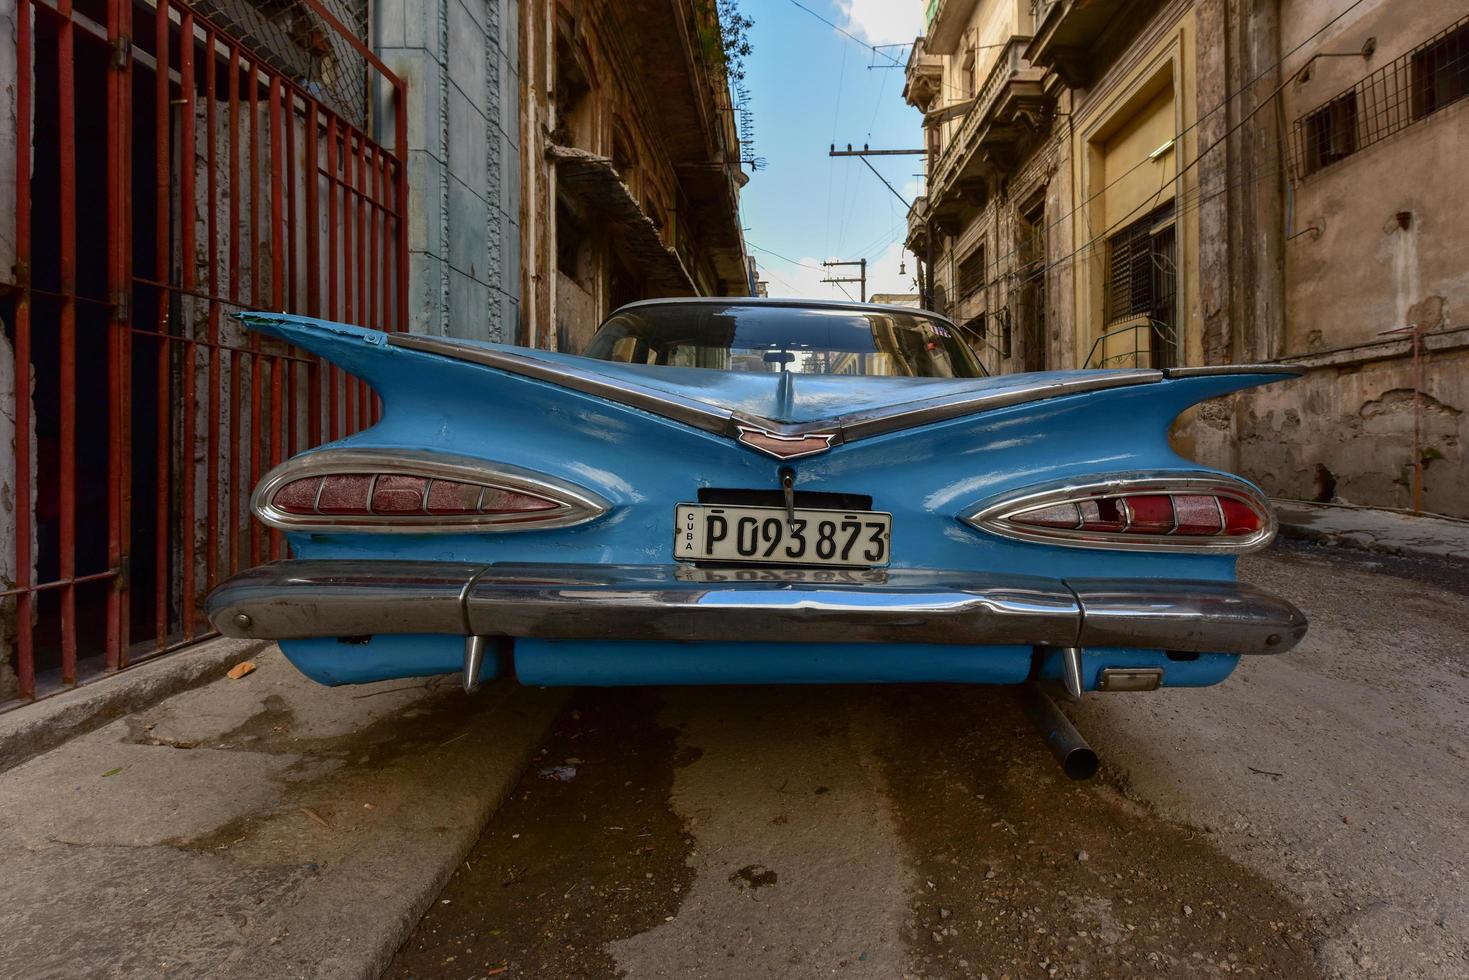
1291 18 1469 178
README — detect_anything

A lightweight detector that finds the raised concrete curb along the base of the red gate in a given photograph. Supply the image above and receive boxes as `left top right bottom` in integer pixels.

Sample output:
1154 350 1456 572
0 636 269 773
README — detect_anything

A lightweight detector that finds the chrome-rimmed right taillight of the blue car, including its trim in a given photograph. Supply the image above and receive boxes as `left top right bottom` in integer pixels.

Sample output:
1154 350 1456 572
964 473 1275 551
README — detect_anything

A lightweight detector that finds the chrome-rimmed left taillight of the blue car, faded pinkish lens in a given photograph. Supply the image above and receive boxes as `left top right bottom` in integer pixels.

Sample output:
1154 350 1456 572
253 450 608 533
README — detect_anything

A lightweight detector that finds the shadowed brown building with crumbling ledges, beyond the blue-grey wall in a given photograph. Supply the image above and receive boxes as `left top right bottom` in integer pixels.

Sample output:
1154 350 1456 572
520 0 751 353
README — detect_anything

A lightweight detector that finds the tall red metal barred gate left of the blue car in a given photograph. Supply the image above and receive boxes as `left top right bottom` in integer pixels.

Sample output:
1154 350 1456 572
0 0 408 701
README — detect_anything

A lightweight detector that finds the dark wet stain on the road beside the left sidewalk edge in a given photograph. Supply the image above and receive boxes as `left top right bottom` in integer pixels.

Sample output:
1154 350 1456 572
383 689 696 980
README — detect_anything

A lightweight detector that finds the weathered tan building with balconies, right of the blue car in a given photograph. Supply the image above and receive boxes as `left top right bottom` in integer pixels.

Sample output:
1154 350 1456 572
905 0 1469 516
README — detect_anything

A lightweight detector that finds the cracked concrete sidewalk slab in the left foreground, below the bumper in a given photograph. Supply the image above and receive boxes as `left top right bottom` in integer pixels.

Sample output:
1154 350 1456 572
0 648 564 979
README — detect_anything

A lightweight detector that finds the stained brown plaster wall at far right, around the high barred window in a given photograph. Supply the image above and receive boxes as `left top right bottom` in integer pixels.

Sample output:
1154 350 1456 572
1234 0 1469 517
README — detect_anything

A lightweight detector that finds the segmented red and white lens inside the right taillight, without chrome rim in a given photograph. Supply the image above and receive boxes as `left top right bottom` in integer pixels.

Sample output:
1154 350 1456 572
1004 480 1271 550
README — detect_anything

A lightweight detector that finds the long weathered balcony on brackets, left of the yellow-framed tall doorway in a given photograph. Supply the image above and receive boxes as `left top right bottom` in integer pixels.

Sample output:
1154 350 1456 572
928 37 1050 208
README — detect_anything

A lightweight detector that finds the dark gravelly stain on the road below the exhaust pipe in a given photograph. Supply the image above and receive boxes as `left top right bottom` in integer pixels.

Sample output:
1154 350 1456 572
878 686 1318 980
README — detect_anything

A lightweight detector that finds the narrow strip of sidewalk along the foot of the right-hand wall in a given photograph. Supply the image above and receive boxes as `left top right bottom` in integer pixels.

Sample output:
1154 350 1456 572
1271 500 1469 561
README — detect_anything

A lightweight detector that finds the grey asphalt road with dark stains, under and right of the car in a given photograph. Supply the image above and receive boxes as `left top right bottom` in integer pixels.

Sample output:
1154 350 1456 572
388 547 1469 980
